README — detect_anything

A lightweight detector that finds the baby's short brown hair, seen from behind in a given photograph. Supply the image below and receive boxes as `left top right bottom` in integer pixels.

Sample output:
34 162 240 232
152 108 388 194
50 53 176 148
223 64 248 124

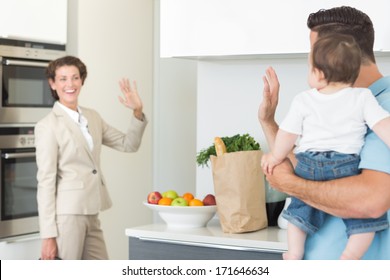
311 34 361 85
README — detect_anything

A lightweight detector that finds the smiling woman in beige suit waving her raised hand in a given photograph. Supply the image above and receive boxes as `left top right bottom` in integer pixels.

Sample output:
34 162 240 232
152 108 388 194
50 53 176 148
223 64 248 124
35 56 147 259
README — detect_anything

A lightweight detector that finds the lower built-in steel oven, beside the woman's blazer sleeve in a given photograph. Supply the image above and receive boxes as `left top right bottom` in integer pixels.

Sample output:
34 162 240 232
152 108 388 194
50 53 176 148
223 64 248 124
0 125 39 238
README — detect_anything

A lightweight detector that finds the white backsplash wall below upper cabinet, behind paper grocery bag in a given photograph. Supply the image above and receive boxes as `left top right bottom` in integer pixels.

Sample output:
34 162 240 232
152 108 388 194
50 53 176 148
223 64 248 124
196 55 307 195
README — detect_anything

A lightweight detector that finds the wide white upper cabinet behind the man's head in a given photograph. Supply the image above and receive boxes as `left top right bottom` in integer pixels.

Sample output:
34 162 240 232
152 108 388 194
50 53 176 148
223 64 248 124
160 0 390 57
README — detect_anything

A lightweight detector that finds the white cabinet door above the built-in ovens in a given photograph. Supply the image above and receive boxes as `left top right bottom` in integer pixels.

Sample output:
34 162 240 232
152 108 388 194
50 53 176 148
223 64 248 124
0 0 68 45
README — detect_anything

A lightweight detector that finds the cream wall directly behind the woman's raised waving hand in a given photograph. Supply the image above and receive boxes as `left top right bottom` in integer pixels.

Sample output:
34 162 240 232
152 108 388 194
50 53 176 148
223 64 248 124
66 0 153 259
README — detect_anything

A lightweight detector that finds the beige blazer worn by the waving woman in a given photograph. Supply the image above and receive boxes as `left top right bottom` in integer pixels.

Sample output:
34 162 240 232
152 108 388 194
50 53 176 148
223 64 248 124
35 103 147 238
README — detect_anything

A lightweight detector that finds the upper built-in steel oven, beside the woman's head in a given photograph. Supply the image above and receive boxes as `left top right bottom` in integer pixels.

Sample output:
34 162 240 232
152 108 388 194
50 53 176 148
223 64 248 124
0 38 65 124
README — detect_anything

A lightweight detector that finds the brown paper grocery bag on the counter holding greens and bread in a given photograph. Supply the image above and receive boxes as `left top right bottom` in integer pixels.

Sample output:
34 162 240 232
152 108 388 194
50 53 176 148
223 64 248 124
211 151 268 233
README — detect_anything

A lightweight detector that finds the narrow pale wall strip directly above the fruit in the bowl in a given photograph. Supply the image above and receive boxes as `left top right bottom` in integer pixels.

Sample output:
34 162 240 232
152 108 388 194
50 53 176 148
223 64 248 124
153 1 197 200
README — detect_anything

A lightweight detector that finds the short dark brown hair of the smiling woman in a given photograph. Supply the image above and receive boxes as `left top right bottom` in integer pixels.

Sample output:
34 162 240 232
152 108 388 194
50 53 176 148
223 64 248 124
46 56 87 100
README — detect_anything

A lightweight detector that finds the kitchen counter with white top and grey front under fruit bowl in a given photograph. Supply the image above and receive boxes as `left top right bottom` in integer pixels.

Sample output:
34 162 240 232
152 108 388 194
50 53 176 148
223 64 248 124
125 218 287 260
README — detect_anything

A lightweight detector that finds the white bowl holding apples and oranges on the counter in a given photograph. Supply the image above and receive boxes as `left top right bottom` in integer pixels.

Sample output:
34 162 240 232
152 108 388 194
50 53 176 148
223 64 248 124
144 202 217 228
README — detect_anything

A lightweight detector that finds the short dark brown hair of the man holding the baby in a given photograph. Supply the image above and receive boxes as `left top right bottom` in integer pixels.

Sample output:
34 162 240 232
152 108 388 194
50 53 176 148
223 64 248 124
307 6 375 63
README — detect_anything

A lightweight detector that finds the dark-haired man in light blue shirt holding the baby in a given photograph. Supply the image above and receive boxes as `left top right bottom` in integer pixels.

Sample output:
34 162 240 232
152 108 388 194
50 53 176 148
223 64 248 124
258 7 390 259
